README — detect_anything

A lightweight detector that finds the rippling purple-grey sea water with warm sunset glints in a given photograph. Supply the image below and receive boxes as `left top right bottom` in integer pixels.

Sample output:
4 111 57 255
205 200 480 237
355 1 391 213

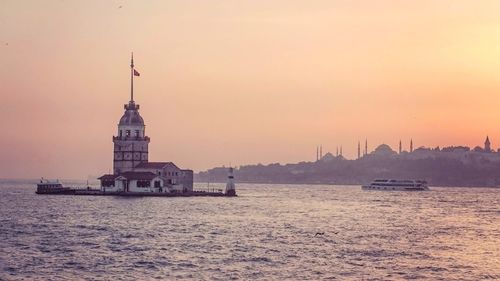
0 181 500 280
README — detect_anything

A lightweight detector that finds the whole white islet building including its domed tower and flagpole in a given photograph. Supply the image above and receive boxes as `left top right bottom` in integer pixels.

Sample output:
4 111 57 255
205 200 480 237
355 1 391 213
99 57 193 192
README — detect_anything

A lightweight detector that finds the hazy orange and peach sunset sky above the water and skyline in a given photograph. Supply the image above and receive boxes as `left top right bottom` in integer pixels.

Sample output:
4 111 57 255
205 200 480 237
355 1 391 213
0 0 500 179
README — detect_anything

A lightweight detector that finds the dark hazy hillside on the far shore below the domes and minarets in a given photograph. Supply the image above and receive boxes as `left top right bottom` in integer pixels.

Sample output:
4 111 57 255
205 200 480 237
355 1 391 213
195 146 500 187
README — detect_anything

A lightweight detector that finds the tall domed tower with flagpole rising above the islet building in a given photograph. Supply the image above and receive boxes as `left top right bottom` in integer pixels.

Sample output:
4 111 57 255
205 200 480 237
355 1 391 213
113 52 149 175
